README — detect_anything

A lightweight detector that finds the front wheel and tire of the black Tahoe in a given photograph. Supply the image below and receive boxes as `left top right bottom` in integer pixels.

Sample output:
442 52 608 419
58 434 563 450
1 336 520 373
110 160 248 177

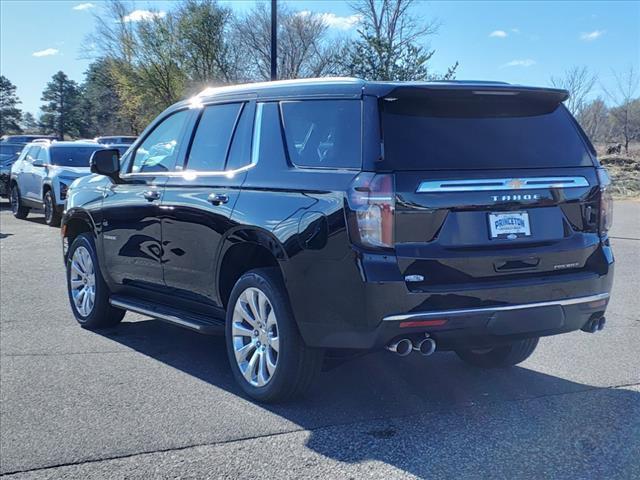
66 233 126 330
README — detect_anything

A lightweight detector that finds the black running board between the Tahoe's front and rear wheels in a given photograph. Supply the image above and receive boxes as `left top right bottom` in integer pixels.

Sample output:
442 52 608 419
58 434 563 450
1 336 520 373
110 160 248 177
109 295 224 335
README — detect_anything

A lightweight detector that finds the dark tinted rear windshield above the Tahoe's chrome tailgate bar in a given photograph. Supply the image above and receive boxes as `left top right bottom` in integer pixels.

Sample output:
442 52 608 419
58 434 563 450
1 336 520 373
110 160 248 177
381 99 593 170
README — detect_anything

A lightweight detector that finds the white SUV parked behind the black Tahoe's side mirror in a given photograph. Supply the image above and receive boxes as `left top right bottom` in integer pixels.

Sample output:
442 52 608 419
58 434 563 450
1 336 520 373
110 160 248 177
9 141 104 226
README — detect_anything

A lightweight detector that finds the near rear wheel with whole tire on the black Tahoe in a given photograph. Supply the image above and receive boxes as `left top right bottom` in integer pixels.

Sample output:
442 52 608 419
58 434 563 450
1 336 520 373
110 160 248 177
225 268 323 403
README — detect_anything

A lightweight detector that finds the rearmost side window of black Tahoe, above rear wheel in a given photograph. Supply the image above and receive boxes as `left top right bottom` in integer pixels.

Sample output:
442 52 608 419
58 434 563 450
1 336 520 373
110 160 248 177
280 100 362 168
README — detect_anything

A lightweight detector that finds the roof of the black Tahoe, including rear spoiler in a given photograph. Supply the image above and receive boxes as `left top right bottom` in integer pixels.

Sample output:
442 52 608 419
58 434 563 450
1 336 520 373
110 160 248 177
189 77 568 106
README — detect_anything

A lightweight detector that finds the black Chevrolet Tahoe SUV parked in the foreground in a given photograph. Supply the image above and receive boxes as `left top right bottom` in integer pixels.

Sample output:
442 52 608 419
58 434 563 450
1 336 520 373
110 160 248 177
62 79 613 401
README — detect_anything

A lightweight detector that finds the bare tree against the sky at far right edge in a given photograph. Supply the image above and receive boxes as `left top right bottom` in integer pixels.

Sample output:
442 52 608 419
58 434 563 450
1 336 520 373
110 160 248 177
602 67 640 153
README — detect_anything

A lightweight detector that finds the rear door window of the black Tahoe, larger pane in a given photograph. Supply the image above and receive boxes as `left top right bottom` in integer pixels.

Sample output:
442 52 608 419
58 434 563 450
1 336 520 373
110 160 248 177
186 103 242 172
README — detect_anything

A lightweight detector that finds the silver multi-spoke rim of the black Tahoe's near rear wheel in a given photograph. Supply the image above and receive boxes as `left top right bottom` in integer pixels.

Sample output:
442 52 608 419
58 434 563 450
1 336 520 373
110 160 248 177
231 287 280 387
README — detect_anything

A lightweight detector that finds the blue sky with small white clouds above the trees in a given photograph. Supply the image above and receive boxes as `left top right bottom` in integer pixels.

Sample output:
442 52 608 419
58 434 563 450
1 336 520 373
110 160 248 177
0 0 640 113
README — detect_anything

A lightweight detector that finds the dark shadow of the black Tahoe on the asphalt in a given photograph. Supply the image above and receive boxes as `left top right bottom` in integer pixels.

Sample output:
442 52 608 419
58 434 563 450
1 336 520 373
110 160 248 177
101 320 640 478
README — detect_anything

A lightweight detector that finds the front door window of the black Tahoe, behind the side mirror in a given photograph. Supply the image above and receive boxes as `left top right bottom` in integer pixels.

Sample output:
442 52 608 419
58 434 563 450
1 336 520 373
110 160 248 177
131 110 191 173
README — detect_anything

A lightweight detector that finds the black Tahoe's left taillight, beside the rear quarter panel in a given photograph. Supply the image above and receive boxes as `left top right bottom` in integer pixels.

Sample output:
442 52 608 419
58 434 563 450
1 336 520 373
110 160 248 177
347 172 396 248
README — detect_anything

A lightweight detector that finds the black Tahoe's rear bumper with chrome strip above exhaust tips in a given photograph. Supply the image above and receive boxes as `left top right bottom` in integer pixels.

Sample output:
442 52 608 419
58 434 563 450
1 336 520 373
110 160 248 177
296 245 614 350
